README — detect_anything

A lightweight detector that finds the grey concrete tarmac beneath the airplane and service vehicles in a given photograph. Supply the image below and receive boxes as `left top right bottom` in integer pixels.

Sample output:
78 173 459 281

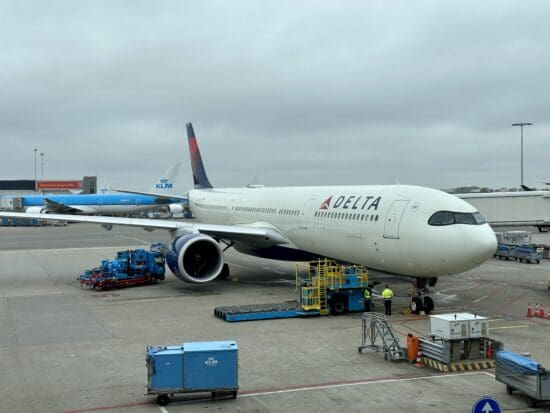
0 224 550 413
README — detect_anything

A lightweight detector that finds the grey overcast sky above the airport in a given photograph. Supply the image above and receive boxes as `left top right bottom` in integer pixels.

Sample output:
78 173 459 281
0 0 550 191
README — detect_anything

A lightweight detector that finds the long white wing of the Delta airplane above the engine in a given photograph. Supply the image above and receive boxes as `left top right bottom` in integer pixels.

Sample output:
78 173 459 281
0 212 289 246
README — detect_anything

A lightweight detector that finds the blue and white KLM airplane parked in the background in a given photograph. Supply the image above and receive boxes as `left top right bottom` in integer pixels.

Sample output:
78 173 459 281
0 163 188 215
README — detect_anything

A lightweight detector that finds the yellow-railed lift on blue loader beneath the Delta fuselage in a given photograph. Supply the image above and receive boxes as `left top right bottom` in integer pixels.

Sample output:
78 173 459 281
296 258 369 315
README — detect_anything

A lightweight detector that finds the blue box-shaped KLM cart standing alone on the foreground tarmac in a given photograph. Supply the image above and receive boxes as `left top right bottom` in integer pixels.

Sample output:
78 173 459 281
145 340 239 406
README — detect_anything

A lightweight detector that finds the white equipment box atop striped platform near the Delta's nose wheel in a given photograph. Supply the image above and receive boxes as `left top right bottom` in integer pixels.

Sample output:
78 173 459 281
428 313 489 340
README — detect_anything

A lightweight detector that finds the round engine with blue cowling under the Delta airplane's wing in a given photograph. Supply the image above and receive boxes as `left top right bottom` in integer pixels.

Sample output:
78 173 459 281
166 234 223 283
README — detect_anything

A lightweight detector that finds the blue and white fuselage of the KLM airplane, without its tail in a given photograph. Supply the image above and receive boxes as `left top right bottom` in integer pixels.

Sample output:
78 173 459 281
4 193 179 215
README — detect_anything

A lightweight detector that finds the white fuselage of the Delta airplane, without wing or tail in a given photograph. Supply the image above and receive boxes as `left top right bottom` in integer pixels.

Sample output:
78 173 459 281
189 185 496 277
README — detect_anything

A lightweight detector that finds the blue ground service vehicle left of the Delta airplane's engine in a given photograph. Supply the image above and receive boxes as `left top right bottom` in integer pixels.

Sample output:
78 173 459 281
77 242 167 290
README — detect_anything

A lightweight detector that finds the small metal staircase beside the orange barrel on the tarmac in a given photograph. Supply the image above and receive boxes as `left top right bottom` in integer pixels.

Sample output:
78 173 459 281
357 313 407 361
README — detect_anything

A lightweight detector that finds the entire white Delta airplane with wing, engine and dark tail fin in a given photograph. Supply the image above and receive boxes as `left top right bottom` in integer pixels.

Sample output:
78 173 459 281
0 123 497 313
